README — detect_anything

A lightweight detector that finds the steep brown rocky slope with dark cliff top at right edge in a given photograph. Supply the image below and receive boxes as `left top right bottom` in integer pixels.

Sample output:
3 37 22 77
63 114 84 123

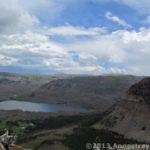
94 78 150 143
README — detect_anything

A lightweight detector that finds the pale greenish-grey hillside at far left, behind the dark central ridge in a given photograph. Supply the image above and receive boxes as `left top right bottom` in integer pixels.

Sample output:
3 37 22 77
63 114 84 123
0 72 67 100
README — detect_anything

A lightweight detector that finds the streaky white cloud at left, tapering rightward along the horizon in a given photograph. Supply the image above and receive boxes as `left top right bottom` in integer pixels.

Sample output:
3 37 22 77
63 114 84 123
0 28 128 74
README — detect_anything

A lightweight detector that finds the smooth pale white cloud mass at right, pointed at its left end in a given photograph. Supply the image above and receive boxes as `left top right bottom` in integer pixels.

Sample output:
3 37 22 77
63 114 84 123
63 28 150 75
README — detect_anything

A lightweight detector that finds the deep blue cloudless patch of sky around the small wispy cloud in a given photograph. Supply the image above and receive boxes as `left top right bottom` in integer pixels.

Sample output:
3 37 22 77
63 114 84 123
40 0 143 31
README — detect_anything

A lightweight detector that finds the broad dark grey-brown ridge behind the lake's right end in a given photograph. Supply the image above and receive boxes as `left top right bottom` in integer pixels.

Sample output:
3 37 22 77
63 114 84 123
24 76 142 111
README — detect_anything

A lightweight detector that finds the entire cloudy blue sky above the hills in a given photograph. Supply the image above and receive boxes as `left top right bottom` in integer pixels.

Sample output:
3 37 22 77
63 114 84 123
0 0 150 76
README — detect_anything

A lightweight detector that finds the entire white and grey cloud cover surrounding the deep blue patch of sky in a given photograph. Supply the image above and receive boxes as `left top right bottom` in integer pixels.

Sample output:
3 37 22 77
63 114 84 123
0 0 150 75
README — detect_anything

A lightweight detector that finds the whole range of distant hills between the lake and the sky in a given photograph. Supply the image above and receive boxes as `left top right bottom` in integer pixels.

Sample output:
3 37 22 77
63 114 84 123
0 73 142 111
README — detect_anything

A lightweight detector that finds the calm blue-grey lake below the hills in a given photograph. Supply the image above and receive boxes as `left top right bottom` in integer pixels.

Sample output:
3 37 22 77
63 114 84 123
0 100 87 112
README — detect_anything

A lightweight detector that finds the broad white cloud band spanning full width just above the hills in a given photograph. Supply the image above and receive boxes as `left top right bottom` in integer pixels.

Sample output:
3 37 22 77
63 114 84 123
0 25 150 75
